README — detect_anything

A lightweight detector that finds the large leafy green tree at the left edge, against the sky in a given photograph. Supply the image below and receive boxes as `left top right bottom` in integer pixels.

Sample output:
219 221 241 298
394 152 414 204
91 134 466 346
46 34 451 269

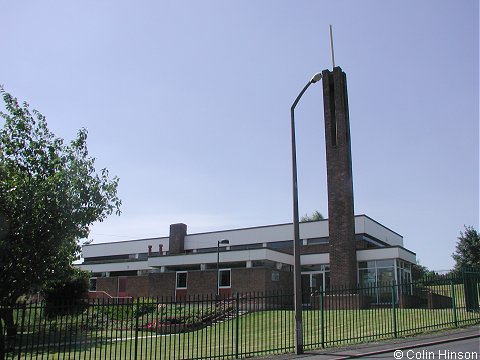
0 87 121 358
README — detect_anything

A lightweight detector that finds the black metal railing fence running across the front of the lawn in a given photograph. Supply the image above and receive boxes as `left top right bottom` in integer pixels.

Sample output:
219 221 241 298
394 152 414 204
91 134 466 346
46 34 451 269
0 272 480 359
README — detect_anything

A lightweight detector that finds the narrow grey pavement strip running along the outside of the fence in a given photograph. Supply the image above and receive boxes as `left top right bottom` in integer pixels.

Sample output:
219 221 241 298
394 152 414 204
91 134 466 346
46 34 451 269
261 325 480 360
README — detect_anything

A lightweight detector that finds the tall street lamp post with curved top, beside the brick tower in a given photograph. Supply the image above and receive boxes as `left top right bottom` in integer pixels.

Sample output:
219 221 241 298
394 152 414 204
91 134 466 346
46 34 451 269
290 73 322 355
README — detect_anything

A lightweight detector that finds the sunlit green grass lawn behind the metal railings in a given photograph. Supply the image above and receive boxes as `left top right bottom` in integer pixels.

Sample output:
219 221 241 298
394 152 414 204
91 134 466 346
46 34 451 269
12 308 480 360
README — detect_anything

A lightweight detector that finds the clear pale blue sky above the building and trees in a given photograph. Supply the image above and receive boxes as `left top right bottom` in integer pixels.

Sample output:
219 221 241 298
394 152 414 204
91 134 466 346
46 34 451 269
0 0 479 270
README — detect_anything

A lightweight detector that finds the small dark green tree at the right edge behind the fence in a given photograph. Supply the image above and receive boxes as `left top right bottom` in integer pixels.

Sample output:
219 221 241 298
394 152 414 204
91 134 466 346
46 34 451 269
452 226 480 270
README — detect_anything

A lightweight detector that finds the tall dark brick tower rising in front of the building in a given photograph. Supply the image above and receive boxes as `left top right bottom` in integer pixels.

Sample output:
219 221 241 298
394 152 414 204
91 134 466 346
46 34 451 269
322 67 357 288
